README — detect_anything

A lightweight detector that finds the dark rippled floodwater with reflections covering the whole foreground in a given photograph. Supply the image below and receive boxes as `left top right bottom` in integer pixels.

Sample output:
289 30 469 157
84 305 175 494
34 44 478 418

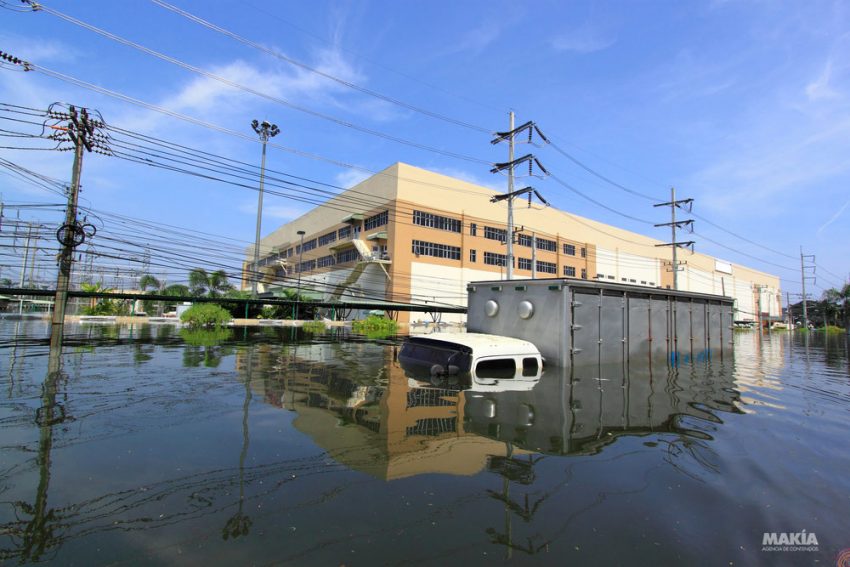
0 321 850 567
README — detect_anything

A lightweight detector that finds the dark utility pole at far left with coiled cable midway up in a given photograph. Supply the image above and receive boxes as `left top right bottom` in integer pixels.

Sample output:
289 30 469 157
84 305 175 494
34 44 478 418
48 105 103 362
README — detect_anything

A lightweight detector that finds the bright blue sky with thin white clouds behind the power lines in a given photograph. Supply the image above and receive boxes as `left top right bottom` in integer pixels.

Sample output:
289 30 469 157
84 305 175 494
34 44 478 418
0 0 850 296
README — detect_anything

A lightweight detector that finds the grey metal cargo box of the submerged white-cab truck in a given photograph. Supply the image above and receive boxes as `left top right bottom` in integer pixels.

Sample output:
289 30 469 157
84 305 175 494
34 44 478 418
467 278 732 366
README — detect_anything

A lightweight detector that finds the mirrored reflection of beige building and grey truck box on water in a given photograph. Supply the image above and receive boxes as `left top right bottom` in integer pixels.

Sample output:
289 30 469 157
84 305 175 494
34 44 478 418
243 344 739 480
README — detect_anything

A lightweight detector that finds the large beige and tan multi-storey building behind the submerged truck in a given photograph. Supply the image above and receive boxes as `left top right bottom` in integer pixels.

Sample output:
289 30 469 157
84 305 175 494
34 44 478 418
243 163 781 322
